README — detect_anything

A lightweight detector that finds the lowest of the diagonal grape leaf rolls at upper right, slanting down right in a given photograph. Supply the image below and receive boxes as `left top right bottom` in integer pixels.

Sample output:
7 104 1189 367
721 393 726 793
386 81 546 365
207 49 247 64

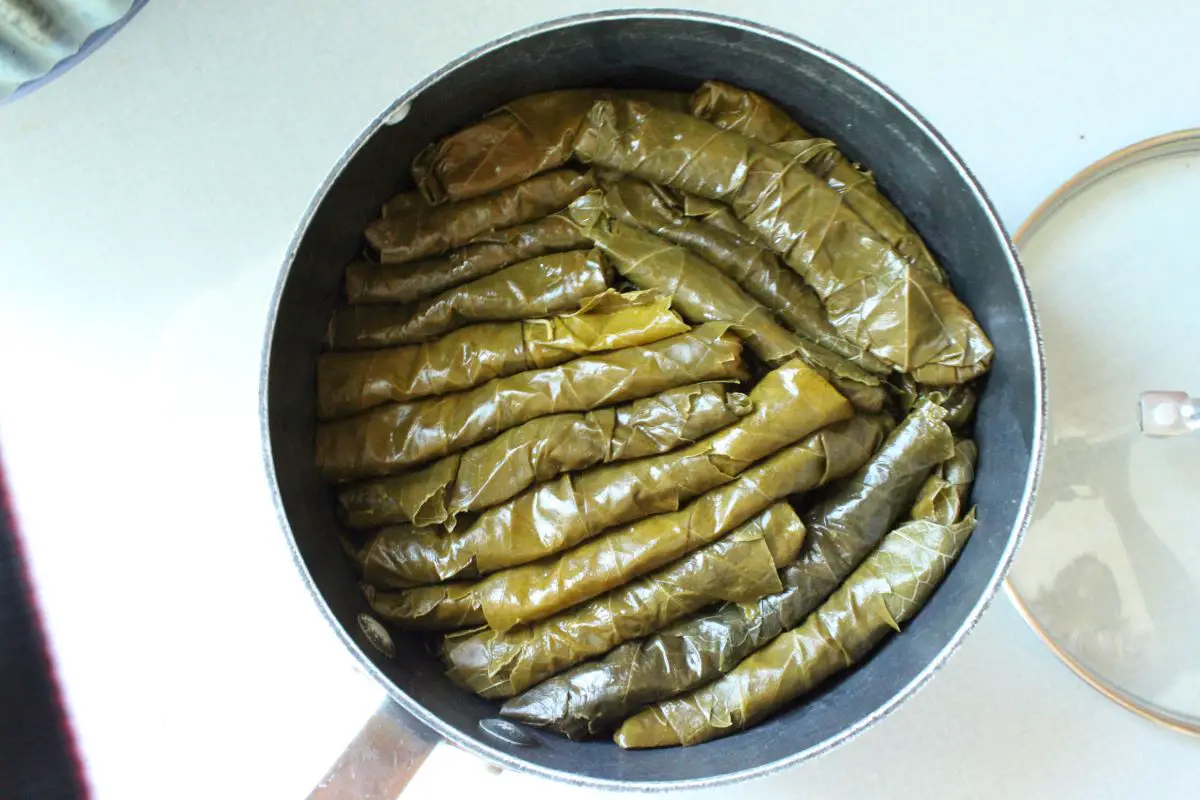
570 193 888 411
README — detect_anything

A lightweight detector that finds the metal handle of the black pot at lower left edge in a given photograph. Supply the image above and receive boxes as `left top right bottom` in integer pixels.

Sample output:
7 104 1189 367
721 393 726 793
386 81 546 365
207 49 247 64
308 699 439 800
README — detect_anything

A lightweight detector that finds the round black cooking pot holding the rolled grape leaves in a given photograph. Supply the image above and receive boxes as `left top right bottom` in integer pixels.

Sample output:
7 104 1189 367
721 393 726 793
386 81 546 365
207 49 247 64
262 12 1044 789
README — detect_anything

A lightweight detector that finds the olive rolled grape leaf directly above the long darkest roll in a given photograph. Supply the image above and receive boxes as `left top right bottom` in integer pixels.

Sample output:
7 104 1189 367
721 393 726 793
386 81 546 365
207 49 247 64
442 503 804 697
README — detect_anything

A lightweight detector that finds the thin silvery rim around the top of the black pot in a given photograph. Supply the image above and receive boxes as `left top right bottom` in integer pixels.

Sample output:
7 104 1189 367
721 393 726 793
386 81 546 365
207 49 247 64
259 8 1046 792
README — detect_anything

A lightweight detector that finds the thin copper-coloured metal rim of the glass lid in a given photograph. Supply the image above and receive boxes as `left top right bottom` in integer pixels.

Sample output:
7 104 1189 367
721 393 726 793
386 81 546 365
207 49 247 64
1004 128 1200 736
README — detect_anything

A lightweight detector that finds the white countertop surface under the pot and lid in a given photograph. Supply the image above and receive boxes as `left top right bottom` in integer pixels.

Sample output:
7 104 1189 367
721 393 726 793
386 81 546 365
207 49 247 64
0 0 1200 800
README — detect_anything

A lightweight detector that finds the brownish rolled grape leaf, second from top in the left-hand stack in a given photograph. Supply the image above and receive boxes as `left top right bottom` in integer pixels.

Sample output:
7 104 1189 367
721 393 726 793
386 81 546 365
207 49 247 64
366 169 595 264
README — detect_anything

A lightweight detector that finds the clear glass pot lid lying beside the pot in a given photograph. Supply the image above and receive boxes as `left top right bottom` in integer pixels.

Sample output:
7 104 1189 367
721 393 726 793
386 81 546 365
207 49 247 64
1008 130 1200 734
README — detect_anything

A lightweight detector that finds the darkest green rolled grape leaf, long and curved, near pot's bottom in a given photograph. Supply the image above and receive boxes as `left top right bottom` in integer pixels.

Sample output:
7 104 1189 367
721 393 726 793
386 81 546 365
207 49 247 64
496 404 954 738
